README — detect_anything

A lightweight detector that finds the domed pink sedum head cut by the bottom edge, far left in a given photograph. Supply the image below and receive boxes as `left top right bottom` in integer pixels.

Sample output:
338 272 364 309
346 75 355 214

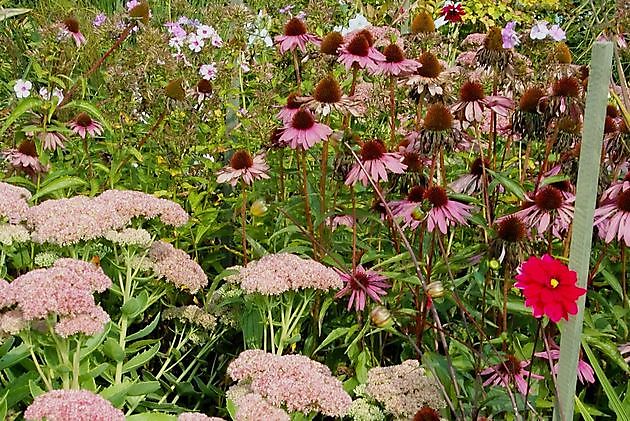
24 390 125 421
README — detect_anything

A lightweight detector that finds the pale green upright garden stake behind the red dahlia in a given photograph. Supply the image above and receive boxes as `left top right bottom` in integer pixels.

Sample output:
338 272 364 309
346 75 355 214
553 42 613 421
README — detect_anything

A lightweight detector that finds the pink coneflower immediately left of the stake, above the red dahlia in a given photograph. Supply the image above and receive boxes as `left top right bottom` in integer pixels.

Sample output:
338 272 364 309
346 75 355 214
514 186 575 238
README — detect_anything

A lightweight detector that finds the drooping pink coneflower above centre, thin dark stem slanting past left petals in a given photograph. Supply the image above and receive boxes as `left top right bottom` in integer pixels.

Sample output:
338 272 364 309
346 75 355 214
345 139 407 186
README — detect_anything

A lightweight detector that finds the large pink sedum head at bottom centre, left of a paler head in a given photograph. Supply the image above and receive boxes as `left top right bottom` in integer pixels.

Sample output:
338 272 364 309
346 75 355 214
228 350 352 417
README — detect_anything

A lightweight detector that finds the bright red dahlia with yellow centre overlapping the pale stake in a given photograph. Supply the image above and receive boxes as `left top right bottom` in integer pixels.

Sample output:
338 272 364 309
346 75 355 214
514 254 586 323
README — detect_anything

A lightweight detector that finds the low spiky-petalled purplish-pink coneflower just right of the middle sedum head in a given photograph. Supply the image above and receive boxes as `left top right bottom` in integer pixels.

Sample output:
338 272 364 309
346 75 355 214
335 265 390 311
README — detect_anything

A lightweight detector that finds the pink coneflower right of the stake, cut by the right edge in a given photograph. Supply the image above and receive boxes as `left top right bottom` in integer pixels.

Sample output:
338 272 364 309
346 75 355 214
594 176 630 247
